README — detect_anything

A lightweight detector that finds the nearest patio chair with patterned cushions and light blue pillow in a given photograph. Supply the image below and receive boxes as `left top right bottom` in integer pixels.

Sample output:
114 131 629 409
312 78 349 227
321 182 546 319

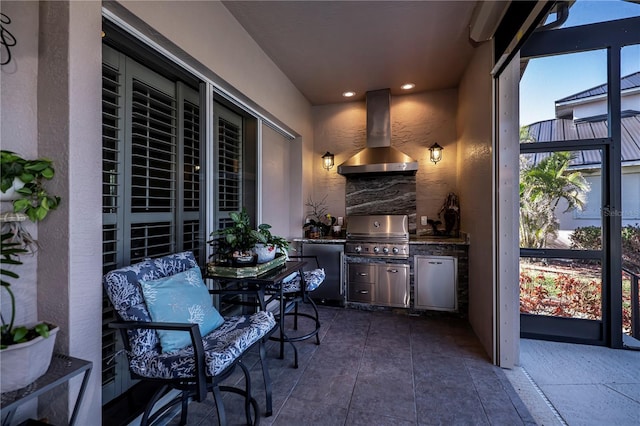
103 252 276 426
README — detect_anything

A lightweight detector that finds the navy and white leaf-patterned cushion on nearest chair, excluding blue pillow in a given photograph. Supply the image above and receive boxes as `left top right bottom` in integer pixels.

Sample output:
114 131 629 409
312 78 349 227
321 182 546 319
103 252 276 378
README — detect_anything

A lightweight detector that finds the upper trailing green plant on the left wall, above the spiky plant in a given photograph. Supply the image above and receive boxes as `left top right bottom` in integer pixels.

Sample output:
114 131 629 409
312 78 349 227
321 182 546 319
0 150 60 222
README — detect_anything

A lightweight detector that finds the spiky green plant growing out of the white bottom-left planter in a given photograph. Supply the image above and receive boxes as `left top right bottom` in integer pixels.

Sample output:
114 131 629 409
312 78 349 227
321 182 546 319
0 232 50 349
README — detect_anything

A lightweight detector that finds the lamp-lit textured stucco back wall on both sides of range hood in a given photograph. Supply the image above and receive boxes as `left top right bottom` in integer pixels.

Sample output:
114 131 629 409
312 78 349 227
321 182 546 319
313 89 465 230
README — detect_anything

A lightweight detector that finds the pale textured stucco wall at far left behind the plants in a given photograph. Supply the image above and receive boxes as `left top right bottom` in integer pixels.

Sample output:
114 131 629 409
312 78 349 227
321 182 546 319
1 2 102 424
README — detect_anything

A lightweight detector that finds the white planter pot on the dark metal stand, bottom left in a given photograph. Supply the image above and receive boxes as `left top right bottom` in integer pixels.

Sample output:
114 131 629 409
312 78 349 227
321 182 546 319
0 327 60 393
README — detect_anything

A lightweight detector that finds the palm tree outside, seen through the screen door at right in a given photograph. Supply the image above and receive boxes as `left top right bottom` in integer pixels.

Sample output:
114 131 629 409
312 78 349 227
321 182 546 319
520 152 589 248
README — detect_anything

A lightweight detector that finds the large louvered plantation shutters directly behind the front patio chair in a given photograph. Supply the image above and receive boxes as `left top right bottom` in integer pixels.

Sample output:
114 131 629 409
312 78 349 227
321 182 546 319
102 46 204 401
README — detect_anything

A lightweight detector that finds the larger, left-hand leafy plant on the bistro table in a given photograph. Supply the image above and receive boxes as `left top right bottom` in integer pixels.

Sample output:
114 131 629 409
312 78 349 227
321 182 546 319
209 207 257 266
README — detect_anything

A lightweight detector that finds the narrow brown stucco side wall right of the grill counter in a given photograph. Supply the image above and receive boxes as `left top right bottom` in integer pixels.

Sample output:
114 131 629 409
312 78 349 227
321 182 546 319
458 43 495 362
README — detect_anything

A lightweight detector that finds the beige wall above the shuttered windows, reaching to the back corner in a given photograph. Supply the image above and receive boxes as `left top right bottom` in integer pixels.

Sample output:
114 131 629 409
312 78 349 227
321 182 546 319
119 1 315 236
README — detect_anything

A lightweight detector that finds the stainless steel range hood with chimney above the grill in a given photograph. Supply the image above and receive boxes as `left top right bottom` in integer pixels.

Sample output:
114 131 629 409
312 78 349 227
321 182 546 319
338 89 418 175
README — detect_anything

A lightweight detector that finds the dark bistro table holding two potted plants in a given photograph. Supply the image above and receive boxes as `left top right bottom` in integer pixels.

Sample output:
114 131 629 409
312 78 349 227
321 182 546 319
204 260 310 368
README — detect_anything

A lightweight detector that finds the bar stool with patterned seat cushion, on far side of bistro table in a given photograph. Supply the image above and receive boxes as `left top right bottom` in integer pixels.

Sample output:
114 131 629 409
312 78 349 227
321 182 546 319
266 256 326 368
